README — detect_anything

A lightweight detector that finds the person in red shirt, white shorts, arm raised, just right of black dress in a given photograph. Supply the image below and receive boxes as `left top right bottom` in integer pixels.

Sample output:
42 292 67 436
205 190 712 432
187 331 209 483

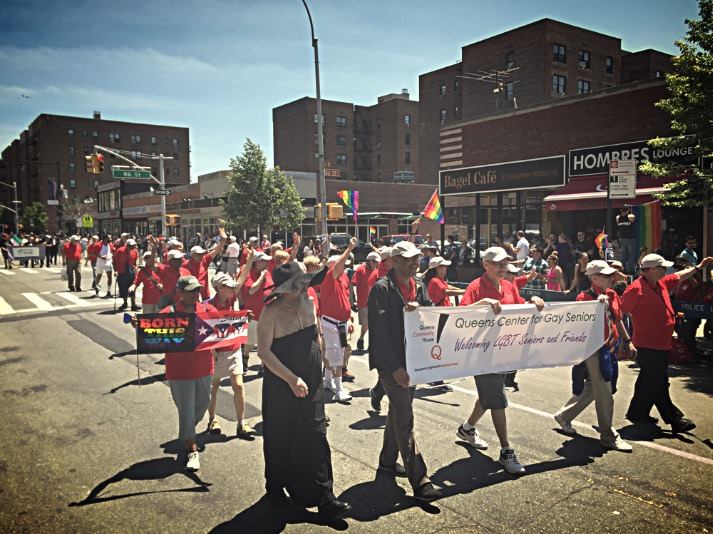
319 237 358 402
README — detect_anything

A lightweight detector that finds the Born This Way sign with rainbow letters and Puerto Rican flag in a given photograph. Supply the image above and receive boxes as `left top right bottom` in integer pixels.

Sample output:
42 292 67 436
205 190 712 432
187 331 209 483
136 311 248 353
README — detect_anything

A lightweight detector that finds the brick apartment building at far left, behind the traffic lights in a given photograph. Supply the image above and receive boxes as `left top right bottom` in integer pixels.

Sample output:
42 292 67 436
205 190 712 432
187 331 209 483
0 112 190 231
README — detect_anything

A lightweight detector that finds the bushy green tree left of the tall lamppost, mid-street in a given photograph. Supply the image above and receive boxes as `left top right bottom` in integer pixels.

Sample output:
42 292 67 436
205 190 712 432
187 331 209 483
221 139 304 231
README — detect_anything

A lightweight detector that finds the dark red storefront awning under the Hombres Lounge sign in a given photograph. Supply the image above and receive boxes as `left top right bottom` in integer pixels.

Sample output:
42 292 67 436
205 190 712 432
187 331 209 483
543 175 675 211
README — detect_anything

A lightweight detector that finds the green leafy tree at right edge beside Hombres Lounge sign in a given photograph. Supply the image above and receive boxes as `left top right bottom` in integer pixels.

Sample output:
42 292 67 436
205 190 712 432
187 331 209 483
640 0 713 209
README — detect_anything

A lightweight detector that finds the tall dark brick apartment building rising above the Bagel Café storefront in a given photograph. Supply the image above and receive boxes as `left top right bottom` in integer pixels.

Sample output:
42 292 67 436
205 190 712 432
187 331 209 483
417 19 671 183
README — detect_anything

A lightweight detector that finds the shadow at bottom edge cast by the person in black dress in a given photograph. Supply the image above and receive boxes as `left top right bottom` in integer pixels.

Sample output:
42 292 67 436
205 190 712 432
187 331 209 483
210 497 349 534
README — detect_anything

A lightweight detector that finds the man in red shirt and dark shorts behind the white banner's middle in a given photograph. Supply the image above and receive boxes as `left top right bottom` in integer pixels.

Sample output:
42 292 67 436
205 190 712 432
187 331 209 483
456 247 545 475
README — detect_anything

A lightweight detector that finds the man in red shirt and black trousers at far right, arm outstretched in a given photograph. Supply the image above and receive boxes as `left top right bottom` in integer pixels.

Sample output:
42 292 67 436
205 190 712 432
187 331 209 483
621 254 713 433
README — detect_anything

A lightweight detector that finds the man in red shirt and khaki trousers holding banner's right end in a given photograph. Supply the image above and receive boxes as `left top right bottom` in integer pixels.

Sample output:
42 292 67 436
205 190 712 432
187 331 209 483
554 260 636 452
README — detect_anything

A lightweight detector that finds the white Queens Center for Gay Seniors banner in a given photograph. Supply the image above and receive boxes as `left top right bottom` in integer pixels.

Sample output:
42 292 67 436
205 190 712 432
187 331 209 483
404 301 607 385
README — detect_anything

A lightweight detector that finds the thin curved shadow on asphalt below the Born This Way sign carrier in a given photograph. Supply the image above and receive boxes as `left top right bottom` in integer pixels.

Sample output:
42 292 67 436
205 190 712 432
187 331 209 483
68 457 212 506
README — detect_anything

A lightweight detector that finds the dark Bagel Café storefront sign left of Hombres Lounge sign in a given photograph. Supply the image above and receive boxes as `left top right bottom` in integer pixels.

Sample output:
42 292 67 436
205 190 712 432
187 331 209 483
439 156 565 195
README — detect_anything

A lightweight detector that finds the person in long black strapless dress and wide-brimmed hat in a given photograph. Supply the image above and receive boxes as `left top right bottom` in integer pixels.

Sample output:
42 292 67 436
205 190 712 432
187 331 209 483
258 262 350 519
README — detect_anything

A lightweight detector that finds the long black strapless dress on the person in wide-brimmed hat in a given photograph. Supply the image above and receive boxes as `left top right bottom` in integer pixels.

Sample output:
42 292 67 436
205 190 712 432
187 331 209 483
262 325 335 508
